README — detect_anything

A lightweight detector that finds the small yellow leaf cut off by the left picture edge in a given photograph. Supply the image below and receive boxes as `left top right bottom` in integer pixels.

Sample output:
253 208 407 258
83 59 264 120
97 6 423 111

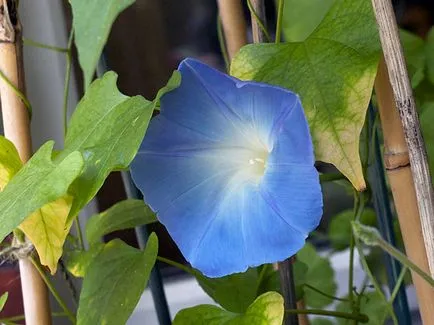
0 136 23 187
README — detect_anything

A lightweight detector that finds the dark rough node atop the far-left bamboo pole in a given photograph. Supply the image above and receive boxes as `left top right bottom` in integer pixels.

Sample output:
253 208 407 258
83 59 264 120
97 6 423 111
0 0 18 43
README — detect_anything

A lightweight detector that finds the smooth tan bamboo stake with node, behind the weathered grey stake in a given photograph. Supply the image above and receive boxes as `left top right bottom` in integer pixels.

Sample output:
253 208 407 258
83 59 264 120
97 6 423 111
375 59 434 325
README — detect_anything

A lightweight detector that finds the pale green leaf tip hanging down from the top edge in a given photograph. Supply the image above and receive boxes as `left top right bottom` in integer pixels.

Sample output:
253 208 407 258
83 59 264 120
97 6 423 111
69 0 135 88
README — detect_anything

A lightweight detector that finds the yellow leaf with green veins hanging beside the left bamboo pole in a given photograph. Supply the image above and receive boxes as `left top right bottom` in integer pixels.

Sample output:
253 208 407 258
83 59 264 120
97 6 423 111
19 195 72 274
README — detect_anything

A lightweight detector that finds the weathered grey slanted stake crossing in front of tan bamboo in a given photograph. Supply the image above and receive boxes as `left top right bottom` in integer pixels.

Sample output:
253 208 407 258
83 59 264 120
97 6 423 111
372 0 434 276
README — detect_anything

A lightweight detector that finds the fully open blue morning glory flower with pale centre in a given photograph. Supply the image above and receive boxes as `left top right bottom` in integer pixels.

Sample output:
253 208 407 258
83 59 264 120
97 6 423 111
131 59 322 277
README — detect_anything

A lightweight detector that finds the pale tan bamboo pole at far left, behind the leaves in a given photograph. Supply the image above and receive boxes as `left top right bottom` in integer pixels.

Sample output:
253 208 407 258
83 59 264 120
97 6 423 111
0 0 51 325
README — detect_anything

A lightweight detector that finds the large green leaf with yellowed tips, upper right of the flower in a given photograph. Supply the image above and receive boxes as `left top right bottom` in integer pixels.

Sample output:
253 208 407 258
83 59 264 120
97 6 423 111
231 0 380 190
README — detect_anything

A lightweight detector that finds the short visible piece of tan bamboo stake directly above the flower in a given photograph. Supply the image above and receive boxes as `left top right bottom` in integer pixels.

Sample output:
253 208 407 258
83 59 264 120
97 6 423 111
217 0 247 59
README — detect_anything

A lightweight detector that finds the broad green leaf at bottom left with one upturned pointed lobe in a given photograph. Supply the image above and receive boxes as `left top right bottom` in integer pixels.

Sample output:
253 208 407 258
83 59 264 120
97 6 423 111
77 234 158 325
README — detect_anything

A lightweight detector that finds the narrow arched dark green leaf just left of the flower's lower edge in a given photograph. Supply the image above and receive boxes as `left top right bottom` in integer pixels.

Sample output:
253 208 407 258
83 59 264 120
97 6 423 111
86 200 157 245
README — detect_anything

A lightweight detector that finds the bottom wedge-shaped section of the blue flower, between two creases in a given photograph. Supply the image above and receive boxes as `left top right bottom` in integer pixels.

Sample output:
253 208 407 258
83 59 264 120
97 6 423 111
190 182 306 277
